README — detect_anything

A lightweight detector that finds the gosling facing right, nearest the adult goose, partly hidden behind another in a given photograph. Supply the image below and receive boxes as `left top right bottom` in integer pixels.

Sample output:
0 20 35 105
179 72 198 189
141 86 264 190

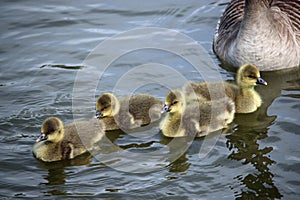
188 64 267 113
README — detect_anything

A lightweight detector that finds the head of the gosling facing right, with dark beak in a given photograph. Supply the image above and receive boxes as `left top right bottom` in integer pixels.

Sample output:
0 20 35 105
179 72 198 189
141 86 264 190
237 64 267 88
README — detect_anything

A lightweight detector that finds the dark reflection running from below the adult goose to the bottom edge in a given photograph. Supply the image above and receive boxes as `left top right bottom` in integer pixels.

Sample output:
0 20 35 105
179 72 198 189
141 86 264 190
226 67 300 199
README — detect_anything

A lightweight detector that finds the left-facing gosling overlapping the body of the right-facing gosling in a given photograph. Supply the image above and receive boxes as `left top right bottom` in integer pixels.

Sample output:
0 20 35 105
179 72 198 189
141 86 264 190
160 90 235 137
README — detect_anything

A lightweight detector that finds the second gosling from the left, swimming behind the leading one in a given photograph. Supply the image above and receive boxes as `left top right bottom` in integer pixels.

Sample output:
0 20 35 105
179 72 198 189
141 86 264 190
96 93 162 131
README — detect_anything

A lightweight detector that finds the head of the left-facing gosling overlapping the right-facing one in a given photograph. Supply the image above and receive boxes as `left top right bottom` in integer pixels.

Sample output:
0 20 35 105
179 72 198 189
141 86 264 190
162 90 184 113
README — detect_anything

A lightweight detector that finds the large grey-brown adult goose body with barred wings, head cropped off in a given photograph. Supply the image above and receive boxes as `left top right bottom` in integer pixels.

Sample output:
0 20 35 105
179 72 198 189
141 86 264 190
213 0 300 71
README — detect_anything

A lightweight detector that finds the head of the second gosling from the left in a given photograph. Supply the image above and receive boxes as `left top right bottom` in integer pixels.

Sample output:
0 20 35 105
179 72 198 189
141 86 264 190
96 93 119 119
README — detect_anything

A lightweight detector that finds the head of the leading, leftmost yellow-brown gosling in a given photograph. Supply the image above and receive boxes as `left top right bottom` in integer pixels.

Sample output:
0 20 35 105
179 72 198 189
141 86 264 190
36 117 64 142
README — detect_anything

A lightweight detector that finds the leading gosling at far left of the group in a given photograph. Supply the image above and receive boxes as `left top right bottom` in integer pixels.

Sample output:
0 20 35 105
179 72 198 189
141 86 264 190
32 117 104 162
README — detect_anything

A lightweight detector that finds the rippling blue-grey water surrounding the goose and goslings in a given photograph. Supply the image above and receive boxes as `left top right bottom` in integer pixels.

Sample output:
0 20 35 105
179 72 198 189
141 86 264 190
0 0 300 199
